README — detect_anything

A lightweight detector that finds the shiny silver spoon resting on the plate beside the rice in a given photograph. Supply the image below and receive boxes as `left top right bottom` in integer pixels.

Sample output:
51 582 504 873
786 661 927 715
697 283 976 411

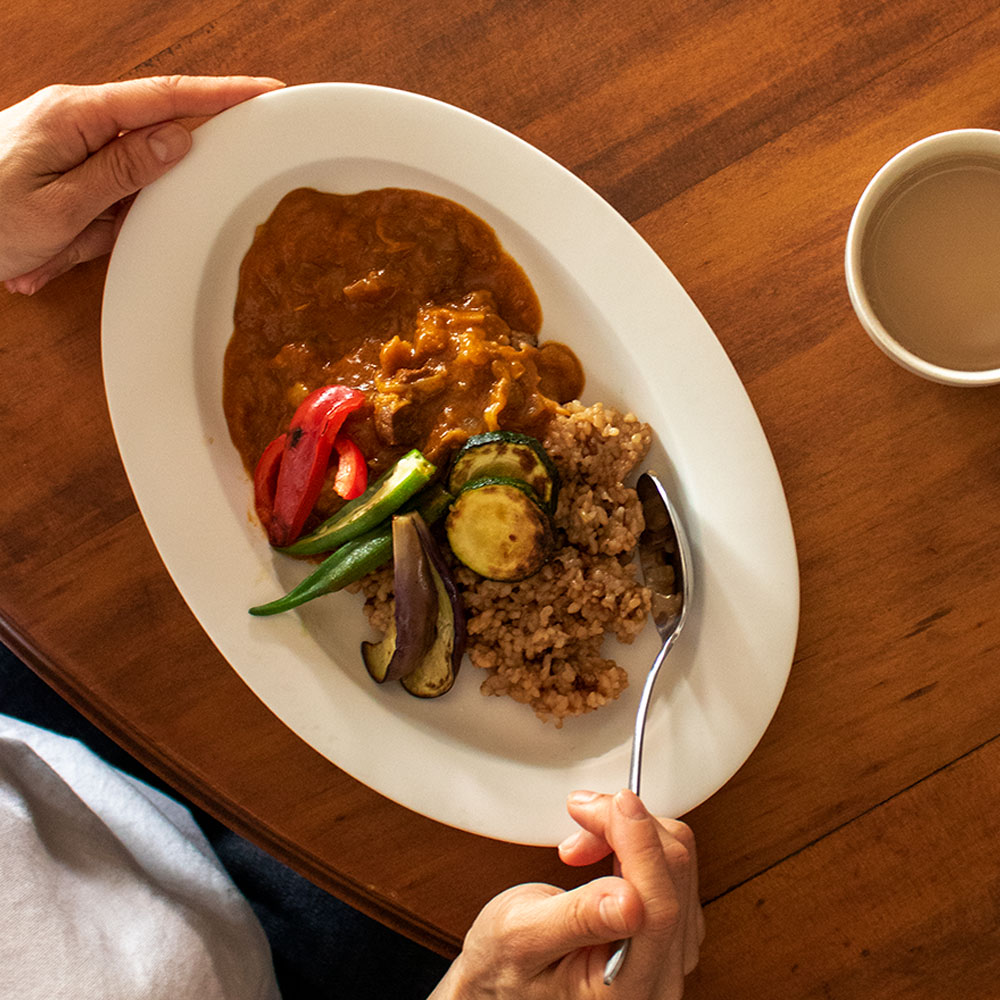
604 472 692 986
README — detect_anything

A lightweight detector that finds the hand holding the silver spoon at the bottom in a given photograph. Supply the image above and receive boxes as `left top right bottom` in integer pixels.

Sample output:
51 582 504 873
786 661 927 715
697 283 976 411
431 791 705 1000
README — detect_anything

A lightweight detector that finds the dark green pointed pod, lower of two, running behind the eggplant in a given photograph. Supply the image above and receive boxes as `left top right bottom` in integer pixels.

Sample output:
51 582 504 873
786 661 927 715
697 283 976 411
250 484 452 617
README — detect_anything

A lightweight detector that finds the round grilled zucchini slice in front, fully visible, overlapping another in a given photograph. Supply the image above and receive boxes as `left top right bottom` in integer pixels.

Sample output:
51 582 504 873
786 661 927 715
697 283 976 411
445 476 554 581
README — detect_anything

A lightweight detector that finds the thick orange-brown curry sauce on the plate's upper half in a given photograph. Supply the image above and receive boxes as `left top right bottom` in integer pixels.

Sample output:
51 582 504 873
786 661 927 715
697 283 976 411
223 188 583 516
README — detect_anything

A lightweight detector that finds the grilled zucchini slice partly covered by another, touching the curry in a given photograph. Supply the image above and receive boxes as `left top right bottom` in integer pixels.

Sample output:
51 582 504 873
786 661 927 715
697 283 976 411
448 431 559 512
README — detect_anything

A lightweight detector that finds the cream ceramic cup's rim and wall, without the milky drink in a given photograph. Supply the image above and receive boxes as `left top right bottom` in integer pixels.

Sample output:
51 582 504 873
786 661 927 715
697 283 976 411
844 128 1000 386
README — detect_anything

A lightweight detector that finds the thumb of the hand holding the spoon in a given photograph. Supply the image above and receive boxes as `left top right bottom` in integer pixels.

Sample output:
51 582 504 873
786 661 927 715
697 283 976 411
516 876 643 969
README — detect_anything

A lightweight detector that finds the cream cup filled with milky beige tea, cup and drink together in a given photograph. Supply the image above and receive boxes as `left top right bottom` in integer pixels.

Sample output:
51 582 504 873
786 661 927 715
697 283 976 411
845 129 1000 385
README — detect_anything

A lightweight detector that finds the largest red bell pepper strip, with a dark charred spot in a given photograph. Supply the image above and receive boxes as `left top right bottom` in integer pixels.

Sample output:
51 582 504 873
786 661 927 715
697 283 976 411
268 385 365 548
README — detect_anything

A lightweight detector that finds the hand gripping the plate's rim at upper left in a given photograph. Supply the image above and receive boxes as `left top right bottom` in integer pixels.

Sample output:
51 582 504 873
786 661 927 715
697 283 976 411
0 76 283 294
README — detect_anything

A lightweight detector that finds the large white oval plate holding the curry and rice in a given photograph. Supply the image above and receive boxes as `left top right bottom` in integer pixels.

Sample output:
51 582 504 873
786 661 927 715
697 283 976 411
102 84 799 844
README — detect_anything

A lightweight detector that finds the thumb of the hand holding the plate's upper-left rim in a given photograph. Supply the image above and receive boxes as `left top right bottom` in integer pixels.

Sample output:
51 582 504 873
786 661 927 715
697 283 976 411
54 122 191 230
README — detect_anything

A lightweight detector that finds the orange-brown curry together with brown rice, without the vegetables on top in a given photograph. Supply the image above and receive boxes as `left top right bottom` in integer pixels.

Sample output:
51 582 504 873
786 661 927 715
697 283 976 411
223 189 651 726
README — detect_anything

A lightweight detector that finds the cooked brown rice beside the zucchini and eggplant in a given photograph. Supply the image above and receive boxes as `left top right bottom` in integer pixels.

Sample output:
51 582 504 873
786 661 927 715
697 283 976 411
361 402 651 726
